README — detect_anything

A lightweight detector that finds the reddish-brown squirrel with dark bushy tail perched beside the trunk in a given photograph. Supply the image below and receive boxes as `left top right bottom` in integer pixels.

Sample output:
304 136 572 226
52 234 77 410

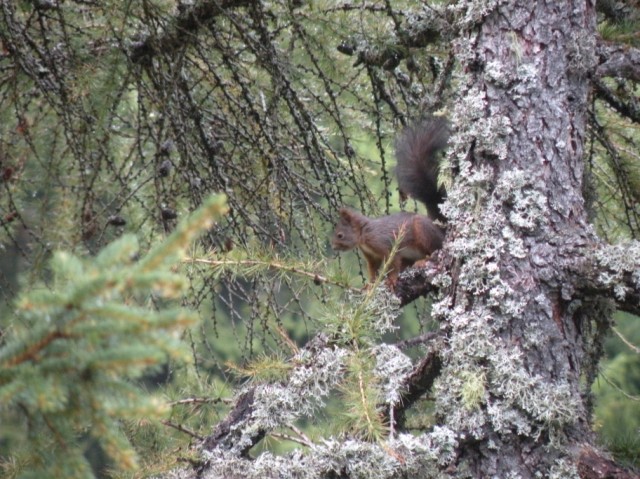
331 118 449 289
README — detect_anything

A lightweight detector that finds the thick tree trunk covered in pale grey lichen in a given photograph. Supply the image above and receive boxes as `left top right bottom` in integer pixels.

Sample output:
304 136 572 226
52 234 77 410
435 0 609 478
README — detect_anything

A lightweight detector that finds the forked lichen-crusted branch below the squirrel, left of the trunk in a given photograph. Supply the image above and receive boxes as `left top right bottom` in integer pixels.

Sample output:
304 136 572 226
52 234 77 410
165 322 458 479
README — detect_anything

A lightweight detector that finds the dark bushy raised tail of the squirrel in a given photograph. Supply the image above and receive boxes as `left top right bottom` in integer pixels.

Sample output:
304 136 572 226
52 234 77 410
396 118 449 222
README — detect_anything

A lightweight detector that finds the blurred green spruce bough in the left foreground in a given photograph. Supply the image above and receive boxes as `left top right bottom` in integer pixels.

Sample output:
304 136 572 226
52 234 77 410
0 195 227 478
